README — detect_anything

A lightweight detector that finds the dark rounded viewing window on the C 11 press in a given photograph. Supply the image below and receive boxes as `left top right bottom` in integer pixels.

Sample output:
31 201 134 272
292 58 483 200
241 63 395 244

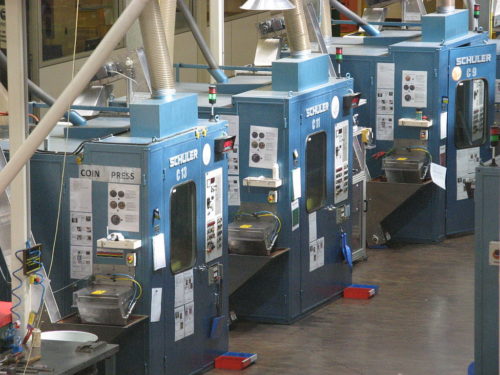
306 132 326 212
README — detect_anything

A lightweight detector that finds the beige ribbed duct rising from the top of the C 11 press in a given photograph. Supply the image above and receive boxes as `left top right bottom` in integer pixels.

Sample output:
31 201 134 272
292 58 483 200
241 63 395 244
283 0 311 56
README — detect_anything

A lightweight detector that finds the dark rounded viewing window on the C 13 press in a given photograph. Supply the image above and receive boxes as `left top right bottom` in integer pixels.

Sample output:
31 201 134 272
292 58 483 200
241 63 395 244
170 181 196 274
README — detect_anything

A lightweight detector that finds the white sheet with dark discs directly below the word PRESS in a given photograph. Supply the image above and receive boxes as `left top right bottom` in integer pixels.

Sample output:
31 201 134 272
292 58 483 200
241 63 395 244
108 184 141 232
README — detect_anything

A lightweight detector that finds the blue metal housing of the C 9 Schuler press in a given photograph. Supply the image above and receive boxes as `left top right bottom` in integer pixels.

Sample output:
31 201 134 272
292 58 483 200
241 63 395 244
329 21 495 242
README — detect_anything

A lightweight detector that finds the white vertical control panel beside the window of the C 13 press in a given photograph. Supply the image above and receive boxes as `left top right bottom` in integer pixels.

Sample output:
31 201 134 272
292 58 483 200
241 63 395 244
205 168 223 262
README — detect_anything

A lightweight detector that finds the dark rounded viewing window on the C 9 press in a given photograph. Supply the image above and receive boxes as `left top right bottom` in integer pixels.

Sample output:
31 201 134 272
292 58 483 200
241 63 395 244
455 79 488 149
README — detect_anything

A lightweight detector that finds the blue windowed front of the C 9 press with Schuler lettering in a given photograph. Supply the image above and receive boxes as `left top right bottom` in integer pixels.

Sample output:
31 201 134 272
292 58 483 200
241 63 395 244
442 45 496 235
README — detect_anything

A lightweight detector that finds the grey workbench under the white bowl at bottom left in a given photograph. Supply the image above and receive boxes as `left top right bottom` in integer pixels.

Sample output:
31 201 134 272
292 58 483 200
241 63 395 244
36 340 118 375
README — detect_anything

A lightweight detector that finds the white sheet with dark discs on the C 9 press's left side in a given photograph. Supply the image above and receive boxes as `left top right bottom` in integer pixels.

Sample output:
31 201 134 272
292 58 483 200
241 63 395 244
401 70 427 108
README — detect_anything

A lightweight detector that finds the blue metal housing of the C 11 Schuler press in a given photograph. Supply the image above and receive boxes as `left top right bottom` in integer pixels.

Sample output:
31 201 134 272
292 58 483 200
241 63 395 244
230 76 353 323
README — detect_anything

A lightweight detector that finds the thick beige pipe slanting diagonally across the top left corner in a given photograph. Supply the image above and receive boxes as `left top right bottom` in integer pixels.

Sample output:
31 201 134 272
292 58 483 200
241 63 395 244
0 0 151 195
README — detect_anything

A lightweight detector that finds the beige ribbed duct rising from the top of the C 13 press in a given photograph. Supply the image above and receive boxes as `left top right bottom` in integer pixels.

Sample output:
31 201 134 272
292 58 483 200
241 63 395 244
139 0 175 98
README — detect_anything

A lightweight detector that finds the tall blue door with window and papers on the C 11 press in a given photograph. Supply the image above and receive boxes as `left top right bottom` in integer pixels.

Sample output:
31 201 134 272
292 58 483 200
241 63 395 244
300 99 336 313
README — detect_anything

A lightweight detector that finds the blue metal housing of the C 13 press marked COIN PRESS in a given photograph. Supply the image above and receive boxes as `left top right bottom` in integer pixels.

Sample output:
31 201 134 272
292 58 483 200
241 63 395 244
20 116 228 375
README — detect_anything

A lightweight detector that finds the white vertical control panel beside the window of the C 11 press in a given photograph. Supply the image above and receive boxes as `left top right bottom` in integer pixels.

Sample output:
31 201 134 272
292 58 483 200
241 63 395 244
335 120 349 203
